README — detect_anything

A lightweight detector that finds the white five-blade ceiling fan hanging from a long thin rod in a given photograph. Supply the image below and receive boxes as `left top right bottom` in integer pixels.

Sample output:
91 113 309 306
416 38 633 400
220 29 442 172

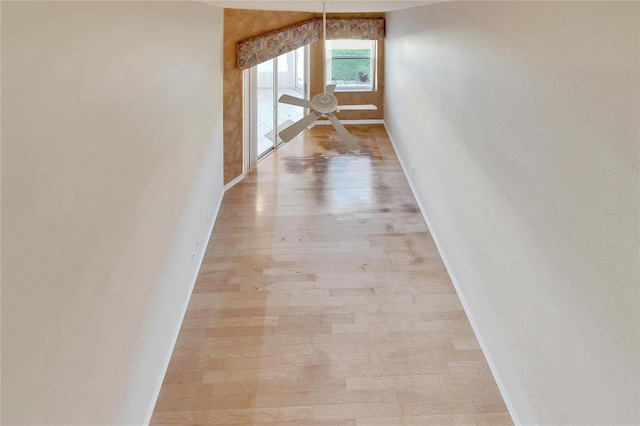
278 0 377 151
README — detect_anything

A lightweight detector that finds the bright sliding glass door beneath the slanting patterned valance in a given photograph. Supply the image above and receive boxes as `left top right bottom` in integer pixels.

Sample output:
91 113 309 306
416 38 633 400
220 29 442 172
244 47 308 170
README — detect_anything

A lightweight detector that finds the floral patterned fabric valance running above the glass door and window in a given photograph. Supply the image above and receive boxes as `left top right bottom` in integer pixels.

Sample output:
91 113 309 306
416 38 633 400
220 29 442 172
236 18 384 70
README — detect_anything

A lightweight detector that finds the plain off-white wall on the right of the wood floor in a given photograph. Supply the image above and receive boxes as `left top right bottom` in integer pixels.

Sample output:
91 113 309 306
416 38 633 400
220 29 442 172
385 2 640 425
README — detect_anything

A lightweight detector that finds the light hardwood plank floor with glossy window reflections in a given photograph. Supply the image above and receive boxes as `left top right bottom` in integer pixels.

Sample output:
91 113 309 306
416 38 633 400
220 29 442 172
151 126 513 426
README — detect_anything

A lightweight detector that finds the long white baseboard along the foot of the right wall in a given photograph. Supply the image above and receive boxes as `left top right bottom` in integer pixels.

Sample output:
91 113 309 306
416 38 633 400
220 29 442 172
383 123 522 425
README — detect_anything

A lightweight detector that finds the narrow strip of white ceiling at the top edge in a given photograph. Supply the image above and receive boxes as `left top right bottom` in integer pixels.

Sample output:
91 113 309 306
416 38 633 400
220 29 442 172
202 0 442 13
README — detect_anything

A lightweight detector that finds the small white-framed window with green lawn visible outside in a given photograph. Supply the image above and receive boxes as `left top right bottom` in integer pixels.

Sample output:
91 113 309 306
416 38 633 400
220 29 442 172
325 40 377 92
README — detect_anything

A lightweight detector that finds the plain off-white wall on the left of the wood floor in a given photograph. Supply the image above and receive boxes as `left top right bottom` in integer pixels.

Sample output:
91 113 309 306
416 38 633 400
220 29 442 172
2 2 223 425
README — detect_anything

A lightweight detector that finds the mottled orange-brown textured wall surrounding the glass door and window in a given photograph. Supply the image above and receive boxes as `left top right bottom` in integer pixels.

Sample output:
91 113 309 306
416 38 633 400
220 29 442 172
224 9 384 183
